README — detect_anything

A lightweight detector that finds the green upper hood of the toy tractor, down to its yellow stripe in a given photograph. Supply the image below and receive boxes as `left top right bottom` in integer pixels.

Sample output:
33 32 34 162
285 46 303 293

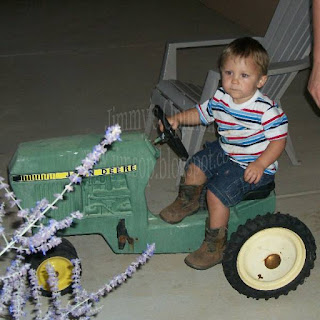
9 133 159 181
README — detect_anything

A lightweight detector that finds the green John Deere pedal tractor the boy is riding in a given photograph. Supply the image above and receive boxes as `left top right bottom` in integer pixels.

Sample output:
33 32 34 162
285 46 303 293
9 107 316 299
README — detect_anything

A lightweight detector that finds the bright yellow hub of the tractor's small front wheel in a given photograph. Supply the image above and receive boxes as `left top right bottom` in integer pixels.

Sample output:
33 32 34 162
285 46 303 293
37 256 73 291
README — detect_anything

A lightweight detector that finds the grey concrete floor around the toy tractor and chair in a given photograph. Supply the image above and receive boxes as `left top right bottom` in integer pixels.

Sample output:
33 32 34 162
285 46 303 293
0 0 320 320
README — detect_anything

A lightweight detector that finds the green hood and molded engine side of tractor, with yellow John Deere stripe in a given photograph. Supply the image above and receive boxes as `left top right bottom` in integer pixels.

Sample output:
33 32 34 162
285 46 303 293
9 133 159 251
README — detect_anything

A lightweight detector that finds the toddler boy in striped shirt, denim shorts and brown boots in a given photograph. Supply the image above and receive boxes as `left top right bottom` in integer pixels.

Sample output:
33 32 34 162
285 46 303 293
160 37 288 269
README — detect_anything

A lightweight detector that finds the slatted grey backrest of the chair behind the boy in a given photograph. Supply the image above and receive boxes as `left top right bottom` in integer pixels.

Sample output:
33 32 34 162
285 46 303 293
261 0 312 100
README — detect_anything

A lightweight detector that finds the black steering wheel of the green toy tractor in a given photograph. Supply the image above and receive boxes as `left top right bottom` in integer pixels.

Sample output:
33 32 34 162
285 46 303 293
153 106 189 161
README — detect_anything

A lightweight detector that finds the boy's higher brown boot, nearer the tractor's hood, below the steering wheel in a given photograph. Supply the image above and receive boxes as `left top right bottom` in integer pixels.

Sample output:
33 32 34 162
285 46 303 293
160 183 204 224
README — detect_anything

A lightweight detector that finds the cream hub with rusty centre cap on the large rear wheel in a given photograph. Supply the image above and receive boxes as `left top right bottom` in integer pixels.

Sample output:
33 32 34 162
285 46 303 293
237 228 306 290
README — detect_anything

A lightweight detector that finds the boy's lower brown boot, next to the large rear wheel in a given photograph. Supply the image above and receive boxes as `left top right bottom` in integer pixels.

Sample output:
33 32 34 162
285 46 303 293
184 222 227 270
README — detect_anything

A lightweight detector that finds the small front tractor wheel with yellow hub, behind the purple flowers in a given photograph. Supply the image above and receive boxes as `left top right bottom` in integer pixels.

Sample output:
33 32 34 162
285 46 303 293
30 238 78 296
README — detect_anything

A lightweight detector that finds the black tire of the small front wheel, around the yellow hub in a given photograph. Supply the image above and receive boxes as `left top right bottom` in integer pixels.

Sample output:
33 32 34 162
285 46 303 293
28 238 78 297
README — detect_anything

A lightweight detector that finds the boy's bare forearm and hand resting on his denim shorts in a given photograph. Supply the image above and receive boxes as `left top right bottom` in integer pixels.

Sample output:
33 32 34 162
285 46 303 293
244 139 286 184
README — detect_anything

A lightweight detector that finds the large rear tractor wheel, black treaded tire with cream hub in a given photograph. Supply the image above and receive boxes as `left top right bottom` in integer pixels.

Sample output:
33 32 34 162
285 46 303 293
222 213 316 300
